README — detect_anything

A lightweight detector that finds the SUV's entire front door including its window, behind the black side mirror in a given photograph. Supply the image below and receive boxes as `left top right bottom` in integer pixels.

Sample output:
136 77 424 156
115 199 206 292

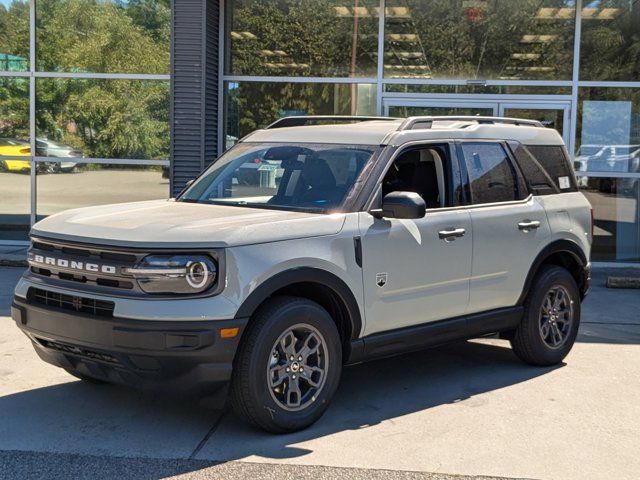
359 144 473 335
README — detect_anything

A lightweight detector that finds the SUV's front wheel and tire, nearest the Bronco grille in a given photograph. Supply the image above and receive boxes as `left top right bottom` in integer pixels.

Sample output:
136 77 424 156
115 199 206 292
230 297 342 433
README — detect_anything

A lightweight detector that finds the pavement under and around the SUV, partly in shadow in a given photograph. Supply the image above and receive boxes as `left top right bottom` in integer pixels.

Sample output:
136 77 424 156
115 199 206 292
0 268 640 479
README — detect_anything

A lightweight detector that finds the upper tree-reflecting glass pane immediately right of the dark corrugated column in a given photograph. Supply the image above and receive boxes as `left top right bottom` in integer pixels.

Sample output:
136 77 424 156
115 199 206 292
225 0 380 77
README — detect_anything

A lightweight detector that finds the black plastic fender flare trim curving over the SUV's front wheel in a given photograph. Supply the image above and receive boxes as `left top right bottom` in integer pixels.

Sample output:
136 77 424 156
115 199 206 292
235 267 362 340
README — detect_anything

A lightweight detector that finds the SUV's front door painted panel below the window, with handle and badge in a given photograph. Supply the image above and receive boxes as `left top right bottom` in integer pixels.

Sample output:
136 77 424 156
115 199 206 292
359 209 473 335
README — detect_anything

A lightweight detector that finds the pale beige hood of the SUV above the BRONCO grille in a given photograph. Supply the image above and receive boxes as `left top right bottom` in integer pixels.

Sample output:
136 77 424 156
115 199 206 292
31 200 345 248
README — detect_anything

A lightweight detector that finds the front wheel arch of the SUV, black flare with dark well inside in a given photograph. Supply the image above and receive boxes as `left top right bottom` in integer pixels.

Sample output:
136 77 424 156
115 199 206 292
235 267 362 358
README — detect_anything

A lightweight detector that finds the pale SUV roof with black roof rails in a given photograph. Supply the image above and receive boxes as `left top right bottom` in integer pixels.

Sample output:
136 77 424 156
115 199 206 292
242 117 564 145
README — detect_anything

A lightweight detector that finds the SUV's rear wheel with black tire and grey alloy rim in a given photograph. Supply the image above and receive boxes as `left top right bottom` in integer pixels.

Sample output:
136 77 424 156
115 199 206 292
511 265 580 366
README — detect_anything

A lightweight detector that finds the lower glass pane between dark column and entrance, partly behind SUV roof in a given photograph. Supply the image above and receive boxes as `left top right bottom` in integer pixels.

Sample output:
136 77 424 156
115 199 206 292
226 82 376 144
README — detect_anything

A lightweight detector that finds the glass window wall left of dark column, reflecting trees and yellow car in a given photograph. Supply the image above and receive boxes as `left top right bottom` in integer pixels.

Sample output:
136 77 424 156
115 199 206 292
0 0 171 243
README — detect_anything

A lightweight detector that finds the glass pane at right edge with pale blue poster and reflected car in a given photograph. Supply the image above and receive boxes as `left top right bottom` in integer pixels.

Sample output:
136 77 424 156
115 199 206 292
574 87 640 174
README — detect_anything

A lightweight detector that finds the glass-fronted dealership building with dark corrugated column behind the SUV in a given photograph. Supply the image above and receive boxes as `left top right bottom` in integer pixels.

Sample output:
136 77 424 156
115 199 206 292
0 0 640 265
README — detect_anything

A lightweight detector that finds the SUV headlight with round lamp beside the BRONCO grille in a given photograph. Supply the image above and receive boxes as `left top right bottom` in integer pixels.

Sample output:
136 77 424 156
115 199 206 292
125 255 218 295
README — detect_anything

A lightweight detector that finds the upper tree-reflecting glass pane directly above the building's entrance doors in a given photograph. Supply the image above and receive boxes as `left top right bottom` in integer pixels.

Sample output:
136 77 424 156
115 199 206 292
384 0 575 80
